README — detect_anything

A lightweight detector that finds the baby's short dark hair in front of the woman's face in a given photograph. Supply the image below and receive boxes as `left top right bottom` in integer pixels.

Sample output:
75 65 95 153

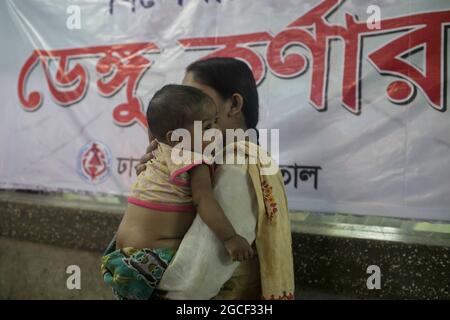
147 84 214 141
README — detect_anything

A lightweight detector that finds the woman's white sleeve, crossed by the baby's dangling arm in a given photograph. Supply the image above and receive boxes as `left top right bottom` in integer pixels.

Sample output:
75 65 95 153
158 165 257 300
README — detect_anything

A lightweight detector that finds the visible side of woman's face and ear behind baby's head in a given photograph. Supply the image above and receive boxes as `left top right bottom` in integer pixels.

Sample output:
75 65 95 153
182 72 236 130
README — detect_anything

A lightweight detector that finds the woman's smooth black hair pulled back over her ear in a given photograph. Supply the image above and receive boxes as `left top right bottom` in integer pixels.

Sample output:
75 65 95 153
186 58 259 130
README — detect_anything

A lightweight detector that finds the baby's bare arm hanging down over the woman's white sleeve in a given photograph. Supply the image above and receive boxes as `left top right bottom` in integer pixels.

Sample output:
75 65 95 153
190 164 253 261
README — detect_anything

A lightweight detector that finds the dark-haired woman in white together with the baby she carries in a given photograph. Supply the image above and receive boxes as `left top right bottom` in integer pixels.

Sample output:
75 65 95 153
102 58 294 299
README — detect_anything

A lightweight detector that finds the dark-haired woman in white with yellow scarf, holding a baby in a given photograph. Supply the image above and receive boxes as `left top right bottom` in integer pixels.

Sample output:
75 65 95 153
103 58 294 299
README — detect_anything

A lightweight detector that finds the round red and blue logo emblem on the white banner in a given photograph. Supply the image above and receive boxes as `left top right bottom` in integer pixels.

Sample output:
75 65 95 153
77 141 111 184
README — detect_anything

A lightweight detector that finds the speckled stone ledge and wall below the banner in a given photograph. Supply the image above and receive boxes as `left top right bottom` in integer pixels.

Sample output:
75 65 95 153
0 191 450 300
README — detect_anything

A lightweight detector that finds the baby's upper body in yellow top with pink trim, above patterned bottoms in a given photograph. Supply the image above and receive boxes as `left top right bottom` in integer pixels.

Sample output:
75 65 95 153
116 85 253 292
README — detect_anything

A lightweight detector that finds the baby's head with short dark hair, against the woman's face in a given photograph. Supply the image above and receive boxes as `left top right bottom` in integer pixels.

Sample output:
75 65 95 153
147 84 217 149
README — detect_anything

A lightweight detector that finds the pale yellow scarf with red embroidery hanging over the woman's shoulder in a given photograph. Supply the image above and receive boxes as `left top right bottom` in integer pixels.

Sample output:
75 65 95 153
232 141 295 300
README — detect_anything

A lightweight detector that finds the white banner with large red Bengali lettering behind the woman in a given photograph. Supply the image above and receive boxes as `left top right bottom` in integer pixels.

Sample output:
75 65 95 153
0 0 450 220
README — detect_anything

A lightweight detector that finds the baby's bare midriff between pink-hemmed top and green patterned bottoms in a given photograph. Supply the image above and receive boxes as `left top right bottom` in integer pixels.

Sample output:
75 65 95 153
117 203 195 249
